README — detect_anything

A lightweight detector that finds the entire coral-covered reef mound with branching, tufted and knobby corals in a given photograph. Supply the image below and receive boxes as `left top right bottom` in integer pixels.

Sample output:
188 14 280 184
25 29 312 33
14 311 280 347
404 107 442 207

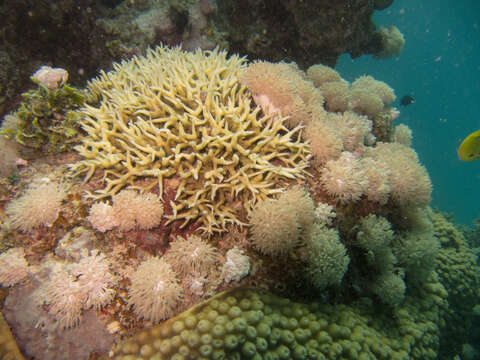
0 45 478 360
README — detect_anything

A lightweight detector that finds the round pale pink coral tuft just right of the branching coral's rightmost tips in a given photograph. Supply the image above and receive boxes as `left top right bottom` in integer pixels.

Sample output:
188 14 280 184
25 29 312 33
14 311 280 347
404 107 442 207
320 151 369 203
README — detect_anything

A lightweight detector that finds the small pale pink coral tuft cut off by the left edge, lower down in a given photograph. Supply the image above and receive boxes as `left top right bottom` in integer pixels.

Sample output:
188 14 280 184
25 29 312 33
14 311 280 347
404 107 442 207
0 248 28 286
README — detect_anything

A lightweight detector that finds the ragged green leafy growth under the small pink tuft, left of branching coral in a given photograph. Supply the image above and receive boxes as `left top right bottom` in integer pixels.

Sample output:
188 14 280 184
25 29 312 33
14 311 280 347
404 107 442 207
0 80 85 152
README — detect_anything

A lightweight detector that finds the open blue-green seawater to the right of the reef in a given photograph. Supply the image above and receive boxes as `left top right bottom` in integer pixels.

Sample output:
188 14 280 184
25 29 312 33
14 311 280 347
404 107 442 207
336 0 480 224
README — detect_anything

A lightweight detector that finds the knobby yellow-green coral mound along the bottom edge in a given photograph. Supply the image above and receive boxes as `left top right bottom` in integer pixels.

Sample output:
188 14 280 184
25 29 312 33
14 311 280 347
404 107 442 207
109 282 447 360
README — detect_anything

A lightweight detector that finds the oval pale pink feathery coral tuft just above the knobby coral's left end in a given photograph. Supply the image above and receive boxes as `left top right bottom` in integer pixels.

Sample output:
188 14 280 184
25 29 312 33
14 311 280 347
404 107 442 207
128 257 183 323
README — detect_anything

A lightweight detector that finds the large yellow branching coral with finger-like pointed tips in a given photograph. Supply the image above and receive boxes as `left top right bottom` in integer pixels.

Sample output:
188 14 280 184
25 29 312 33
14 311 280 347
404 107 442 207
71 47 310 232
